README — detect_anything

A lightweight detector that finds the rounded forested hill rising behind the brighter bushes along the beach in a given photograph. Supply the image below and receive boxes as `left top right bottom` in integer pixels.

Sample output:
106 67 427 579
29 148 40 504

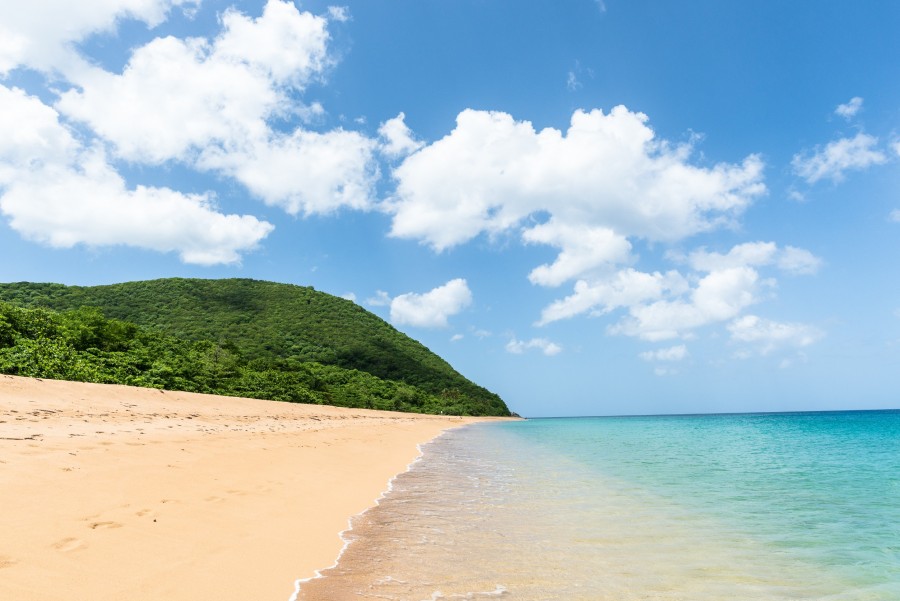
0 278 509 415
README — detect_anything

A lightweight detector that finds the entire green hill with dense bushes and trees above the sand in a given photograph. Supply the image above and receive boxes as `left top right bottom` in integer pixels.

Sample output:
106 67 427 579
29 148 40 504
0 279 509 415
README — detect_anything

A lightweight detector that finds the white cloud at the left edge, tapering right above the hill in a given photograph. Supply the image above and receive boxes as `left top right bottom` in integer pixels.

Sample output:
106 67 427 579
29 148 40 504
0 85 273 265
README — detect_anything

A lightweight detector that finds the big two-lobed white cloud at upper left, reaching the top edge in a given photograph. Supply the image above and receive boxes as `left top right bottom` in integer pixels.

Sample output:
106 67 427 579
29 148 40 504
57 0 379 215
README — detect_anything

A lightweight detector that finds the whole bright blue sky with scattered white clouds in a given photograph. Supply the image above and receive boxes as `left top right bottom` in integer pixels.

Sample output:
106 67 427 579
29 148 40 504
0 0 900 416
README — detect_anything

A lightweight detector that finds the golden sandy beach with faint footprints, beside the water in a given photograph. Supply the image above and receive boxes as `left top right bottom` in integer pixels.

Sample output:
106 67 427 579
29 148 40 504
0 376 492 601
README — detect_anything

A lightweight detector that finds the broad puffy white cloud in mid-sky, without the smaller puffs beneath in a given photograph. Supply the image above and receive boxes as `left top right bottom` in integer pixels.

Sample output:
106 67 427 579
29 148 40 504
389 106 765 254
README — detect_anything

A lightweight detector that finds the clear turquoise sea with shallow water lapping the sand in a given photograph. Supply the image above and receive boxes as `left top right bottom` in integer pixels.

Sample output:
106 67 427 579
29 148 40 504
297 411 900 601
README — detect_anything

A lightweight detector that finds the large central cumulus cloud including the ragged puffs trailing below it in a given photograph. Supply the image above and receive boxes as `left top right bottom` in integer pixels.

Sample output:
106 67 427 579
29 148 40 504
386 106 768 338
